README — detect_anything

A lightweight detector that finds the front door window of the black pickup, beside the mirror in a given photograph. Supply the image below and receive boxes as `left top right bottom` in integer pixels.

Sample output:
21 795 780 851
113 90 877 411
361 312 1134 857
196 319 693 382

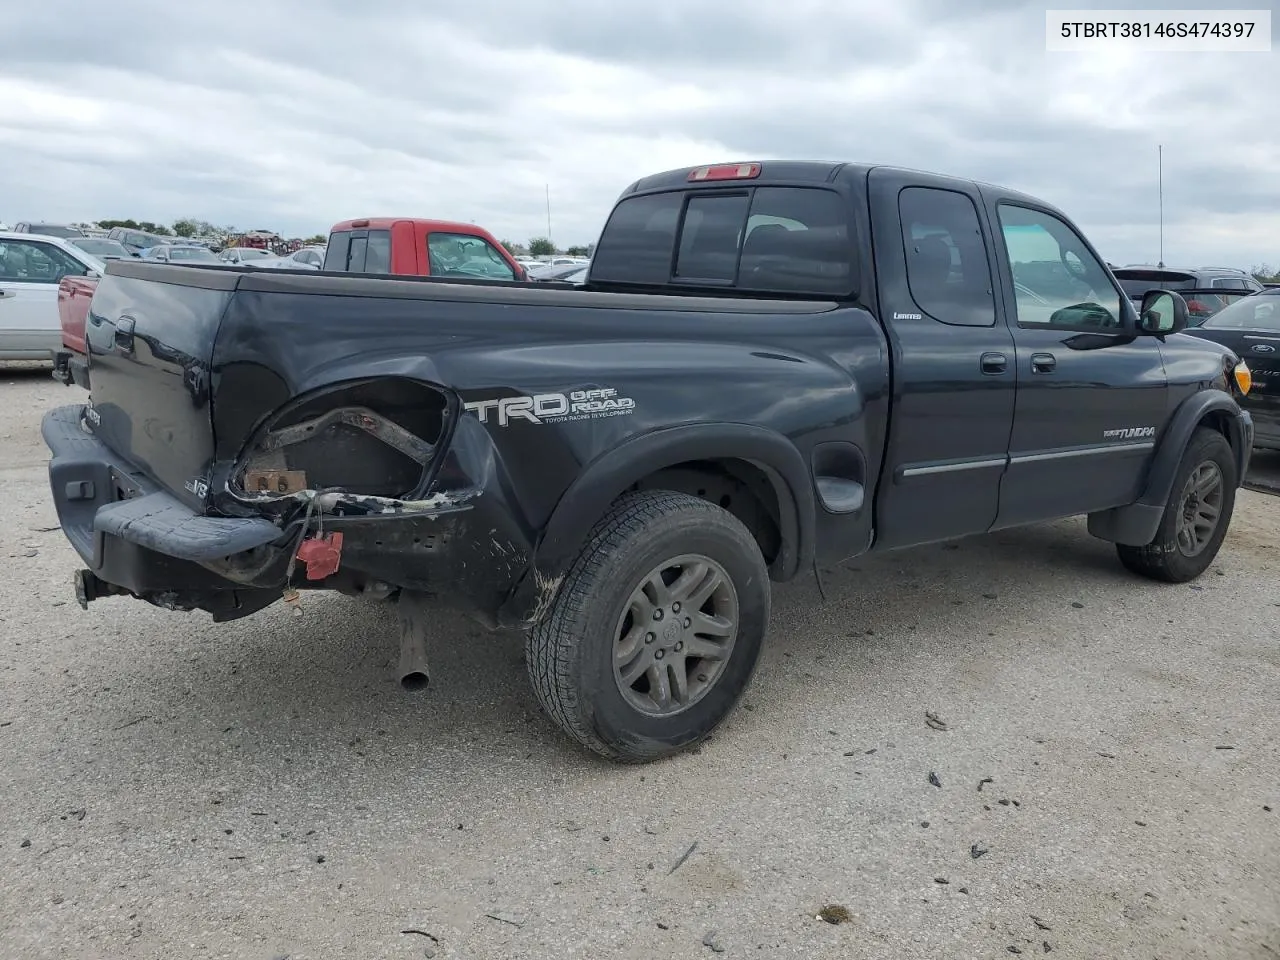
998 204 1124 330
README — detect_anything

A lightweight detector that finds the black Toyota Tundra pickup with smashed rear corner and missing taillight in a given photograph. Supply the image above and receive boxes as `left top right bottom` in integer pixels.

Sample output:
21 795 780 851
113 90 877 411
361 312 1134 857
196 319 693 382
44 163 1253 762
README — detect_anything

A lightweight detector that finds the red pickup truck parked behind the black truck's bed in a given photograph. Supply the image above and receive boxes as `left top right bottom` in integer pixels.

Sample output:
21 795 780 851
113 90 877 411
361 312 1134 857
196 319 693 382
54 216 519 389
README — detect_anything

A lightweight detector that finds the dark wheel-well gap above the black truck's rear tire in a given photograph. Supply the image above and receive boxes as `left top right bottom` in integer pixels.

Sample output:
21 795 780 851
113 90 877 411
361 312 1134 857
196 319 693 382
627 458 782 566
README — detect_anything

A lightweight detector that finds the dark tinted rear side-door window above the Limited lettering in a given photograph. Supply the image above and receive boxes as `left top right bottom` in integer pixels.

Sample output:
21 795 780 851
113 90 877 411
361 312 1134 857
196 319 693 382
899 187 996 326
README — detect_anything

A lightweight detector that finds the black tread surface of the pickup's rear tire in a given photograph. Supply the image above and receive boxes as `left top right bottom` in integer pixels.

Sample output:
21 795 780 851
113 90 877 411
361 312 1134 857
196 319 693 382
525 490 750 763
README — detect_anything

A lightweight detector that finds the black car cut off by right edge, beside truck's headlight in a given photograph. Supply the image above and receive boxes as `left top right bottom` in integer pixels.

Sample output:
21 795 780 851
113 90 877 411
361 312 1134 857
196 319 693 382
1188 288 1280 451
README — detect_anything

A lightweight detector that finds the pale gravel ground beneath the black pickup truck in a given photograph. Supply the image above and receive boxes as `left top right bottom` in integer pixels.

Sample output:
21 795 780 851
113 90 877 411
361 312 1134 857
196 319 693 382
0 369 1280 960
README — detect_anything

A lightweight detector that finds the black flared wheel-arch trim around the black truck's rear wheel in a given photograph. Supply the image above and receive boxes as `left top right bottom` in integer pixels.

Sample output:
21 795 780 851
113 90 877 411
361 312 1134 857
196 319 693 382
499 424 815 626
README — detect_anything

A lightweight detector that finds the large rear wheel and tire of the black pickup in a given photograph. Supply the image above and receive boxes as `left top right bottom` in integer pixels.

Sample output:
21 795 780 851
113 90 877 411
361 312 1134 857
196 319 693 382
525 490 771 763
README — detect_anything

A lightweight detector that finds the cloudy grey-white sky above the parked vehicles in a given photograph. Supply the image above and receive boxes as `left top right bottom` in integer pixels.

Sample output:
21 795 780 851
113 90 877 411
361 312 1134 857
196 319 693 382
0 0 1280 268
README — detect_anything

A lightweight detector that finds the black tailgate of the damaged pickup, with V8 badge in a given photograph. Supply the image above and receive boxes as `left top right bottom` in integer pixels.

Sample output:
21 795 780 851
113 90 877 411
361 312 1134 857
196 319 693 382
86 261 239 511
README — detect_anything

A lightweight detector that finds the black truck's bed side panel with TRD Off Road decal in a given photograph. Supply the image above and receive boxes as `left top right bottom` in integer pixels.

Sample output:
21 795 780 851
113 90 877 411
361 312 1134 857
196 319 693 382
212 275 887 624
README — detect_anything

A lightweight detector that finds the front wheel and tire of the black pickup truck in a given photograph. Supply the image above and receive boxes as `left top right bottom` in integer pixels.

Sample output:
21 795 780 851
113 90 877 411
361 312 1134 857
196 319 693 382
1116 428 1239 584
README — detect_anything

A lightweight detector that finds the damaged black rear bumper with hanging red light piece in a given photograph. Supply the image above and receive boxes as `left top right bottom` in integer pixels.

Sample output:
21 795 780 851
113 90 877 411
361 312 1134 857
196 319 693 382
42 404 531 623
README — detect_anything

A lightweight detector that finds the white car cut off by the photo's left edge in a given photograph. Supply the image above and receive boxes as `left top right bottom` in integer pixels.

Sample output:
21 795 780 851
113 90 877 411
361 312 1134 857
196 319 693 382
0 230 106 360
